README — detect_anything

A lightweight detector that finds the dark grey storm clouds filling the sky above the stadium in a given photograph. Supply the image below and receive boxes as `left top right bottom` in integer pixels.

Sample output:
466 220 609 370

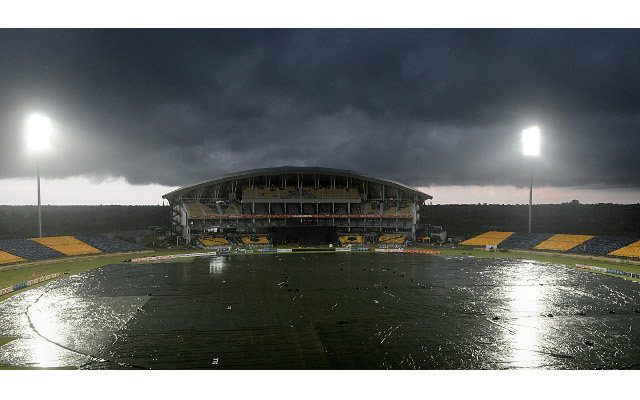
0 29 640 188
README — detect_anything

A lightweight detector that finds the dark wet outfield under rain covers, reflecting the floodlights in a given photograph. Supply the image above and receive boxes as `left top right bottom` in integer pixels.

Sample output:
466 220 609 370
0 253 640 369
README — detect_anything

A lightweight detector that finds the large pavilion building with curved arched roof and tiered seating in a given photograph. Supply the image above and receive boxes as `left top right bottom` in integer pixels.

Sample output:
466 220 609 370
162 167 433 246
